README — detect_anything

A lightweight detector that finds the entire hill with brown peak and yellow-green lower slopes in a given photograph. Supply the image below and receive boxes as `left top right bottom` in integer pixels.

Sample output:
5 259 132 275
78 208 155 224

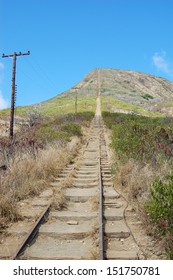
0 68 173 117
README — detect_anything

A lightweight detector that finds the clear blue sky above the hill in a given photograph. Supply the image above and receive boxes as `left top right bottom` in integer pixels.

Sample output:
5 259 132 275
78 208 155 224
0 0 173 109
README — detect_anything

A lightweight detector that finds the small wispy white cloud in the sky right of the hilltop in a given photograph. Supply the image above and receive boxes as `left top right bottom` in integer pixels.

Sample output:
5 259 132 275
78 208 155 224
152 51 173 74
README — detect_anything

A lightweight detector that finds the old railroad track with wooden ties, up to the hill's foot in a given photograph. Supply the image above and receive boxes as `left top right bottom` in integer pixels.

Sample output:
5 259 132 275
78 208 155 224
14 116 139 260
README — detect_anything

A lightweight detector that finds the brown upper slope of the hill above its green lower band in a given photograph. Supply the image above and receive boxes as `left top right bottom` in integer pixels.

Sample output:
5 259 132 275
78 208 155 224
59 68 173 115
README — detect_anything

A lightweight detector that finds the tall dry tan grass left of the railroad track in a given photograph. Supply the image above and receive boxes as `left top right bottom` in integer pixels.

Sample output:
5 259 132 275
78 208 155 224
0 140 80 227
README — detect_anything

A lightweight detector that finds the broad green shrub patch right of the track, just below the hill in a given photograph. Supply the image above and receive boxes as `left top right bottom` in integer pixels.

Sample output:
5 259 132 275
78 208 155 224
103 112 173 163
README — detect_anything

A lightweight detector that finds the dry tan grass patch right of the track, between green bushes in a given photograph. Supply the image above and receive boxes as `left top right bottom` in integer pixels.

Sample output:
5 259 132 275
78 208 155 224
114 159 171 232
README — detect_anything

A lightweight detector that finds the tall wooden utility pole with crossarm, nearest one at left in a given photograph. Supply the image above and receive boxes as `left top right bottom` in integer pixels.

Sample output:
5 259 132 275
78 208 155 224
2 51 30 142
